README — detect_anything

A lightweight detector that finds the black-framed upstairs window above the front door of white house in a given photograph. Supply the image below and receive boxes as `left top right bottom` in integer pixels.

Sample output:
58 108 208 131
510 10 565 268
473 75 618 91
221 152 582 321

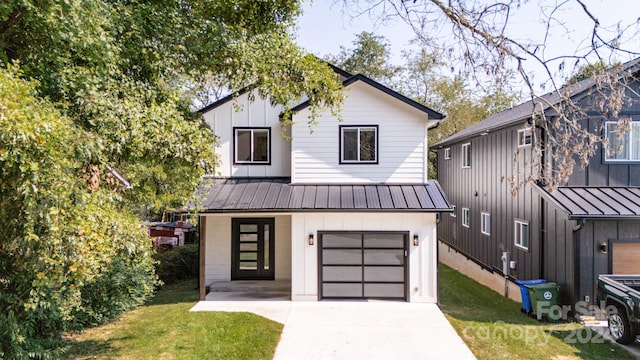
233 128 271 165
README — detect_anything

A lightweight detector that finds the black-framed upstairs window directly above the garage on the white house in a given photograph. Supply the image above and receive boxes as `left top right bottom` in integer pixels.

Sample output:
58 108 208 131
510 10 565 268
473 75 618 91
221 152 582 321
340 125 378 164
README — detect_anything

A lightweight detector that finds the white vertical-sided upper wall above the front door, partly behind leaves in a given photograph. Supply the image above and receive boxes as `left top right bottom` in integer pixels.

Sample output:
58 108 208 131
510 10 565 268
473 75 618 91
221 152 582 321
203 93 291 177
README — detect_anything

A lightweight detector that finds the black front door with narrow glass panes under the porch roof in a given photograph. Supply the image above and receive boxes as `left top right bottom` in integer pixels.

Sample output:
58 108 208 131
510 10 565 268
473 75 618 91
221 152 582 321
231 218 275 280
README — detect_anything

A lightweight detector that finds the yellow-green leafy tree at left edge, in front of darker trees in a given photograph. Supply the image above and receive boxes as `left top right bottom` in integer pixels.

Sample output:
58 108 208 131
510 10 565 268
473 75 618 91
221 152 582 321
0 66 155 358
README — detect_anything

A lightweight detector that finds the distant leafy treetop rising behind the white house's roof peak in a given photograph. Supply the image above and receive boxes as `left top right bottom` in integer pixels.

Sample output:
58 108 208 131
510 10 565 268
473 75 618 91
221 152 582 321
327 31 400 84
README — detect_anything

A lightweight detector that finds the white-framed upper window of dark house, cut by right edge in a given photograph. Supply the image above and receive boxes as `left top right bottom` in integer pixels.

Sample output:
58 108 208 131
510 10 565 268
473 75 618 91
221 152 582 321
605 121 640 161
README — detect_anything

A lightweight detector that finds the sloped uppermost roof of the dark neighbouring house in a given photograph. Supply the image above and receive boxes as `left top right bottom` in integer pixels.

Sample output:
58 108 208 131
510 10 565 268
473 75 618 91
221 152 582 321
431 58 640 148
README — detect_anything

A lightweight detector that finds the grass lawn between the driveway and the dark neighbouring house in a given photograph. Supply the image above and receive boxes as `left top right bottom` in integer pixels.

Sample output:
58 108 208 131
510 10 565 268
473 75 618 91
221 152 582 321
439 265 634 360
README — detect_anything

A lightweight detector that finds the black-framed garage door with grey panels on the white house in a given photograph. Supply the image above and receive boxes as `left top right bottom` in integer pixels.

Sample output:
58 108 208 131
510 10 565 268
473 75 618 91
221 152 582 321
318 232 409 300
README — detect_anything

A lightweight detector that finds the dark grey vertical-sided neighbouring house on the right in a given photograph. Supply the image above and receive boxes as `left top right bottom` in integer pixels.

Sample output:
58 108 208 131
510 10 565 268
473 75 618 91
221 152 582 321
432 60 640 310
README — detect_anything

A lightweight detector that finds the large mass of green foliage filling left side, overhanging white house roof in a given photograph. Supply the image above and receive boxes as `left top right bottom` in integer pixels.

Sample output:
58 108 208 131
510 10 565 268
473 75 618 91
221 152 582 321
0 0 342 358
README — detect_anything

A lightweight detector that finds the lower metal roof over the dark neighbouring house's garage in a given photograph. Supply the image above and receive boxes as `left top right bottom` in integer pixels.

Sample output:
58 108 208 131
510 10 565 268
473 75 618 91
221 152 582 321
541 186 640 220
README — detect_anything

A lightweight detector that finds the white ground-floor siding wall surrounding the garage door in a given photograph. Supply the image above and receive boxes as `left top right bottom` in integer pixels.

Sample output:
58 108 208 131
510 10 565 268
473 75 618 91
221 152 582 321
292 213 437 303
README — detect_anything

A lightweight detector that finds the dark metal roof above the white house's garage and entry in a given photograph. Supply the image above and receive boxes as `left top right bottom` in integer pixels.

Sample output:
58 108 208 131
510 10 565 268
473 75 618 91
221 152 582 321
197 178 452 213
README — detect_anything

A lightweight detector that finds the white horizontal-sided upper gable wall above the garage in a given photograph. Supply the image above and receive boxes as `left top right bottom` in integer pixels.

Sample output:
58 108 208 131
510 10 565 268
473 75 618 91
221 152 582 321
291 82 428 184
